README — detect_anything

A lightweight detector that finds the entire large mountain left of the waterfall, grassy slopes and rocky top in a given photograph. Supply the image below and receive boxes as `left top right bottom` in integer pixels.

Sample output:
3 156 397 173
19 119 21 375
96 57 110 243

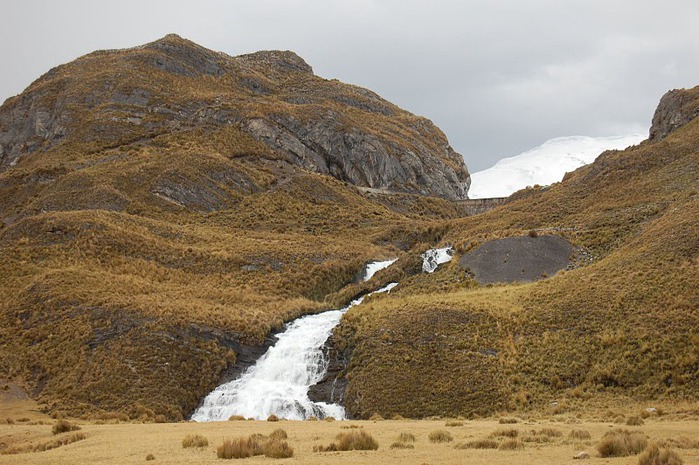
0 36 468 420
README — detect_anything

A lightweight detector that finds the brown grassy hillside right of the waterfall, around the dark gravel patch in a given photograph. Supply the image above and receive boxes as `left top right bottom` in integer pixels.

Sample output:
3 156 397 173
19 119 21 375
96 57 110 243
336 88 699 417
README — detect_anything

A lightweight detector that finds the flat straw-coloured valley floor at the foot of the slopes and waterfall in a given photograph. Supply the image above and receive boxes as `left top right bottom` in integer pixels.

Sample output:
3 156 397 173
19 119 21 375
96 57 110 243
0 396 699 465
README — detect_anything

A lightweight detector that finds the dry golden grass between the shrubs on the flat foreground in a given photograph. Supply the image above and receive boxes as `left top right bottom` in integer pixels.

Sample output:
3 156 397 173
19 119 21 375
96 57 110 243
0 416 699 465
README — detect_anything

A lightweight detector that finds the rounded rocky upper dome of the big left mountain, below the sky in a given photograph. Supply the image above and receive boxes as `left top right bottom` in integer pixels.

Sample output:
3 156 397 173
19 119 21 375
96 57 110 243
0 35 470 199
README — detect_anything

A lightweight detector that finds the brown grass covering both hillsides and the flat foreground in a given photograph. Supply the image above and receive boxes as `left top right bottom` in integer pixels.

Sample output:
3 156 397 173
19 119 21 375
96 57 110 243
0 32 699 464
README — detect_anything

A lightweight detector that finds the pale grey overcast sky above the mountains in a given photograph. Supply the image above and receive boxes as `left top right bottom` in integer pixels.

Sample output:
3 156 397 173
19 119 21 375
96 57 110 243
0 0 699 171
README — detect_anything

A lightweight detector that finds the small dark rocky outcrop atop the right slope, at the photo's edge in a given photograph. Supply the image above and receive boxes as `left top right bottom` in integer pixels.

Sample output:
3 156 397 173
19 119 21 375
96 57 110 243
648 87 699 140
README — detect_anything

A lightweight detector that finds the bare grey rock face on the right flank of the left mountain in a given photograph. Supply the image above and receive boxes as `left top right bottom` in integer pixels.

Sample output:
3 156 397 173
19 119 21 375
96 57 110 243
241 110 471 200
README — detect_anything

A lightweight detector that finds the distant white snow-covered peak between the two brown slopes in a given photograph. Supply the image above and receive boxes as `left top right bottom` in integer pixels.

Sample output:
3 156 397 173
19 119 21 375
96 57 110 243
468 134 646 199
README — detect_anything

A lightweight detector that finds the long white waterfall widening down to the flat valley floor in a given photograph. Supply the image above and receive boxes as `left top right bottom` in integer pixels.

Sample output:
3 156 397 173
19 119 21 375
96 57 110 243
192 260 397 421
